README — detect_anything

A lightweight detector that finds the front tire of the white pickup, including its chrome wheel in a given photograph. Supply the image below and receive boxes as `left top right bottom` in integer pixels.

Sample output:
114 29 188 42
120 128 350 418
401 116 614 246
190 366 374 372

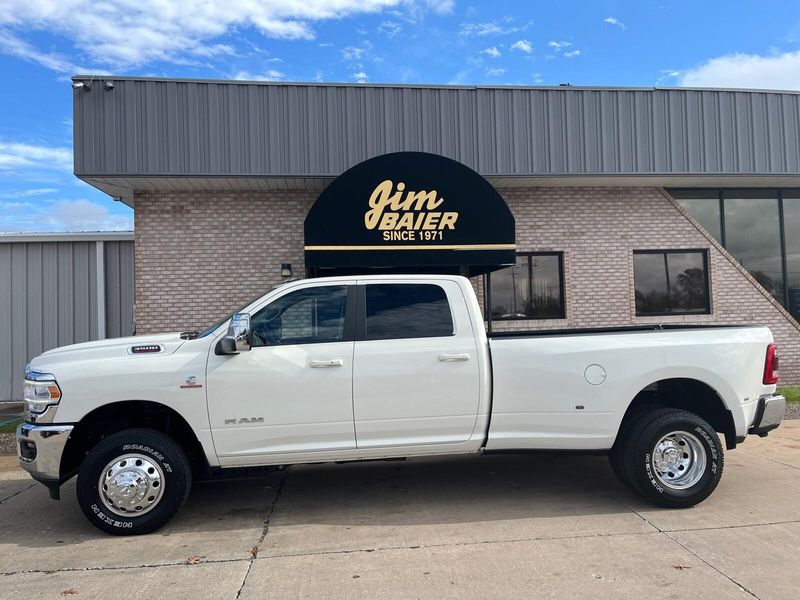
77 429 192 535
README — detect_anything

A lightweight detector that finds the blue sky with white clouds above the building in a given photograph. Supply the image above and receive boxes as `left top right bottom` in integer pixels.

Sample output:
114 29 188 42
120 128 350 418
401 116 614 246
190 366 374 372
0 0 800 232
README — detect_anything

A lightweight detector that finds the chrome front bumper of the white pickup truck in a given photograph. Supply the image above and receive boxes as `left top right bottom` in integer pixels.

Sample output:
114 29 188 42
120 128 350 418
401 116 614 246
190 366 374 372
17 423 74 498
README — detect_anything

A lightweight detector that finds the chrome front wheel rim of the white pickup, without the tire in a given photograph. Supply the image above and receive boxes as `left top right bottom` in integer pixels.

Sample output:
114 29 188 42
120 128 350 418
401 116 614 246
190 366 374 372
97 454 164 517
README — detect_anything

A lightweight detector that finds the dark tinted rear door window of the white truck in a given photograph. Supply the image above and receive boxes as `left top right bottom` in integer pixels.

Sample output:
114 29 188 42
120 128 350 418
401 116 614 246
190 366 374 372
366 283 453 340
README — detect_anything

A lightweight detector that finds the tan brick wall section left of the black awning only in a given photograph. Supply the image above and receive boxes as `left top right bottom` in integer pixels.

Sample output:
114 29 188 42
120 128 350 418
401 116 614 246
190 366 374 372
134 191 310 334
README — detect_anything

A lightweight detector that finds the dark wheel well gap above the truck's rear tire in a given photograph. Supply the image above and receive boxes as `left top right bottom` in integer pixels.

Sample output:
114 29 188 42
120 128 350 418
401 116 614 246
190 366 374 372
620 378 736 450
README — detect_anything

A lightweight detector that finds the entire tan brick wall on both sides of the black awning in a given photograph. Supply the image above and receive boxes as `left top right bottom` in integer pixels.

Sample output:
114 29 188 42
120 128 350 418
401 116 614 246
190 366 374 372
135 188 800 383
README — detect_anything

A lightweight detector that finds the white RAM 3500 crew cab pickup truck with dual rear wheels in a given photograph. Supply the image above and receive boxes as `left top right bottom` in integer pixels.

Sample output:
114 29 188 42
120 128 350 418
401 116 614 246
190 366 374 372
17 275 785 534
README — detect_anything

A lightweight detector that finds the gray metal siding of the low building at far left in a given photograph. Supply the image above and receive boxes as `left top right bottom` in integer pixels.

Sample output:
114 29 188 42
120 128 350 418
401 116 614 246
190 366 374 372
0 240 133 401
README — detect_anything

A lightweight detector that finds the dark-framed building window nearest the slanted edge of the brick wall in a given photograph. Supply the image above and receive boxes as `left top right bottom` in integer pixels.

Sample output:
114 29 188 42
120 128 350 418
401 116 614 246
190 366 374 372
633 250 711 317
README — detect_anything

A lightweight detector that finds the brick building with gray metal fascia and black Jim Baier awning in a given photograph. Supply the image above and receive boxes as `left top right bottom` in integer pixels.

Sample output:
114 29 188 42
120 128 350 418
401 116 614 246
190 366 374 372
69 77 800 383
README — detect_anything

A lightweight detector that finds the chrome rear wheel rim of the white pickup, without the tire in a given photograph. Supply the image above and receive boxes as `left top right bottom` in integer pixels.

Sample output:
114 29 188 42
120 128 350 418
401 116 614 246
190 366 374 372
651 431 706 490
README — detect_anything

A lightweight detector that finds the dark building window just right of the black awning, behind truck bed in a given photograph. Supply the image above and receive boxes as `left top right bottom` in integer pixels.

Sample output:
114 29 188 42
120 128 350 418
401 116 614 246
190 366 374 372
486 252 564 320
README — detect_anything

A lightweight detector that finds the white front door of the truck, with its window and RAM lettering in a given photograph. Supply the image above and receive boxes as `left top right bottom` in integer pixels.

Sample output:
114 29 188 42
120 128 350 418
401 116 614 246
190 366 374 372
207 283 355 464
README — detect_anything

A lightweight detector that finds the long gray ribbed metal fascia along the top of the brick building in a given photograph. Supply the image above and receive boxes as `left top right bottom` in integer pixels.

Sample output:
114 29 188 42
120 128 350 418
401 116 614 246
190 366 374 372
73 79 800 183
